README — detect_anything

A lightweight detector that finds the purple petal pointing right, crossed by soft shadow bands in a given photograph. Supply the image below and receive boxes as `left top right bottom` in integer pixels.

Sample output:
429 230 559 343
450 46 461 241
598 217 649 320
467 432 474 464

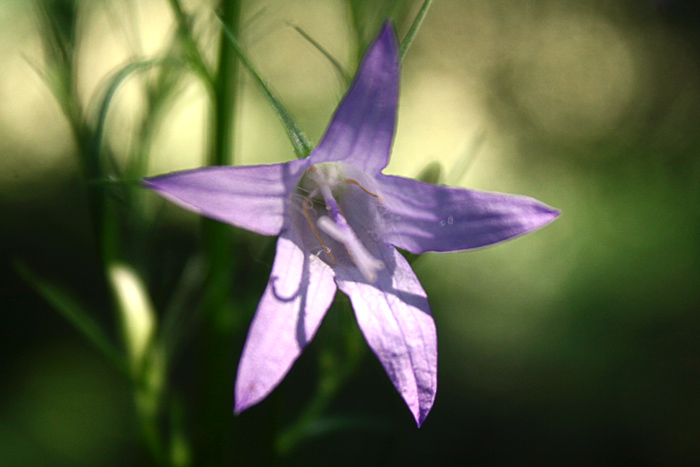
377 175 559 253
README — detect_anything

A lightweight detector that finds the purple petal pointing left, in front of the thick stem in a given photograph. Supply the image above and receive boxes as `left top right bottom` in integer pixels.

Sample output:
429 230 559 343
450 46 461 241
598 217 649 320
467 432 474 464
145 159 309 235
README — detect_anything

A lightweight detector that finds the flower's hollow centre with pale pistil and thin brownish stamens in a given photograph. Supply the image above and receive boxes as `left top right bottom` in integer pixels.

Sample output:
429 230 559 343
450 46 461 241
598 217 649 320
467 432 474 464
297 163 384 282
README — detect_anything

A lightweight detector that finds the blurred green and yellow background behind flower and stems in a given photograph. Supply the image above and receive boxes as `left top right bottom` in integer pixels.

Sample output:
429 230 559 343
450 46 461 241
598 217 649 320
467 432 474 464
0 0 700 467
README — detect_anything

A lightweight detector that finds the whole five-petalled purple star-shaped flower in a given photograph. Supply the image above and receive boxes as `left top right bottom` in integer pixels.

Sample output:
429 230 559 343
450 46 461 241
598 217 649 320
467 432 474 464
146 23 558 425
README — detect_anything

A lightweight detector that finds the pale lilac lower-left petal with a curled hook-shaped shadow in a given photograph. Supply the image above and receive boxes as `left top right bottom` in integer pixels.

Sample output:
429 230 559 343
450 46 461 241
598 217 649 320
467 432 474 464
234 232 336 413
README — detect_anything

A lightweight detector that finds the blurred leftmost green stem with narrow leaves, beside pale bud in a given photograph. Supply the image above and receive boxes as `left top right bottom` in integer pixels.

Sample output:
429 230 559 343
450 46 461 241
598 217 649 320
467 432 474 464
42 0 179 466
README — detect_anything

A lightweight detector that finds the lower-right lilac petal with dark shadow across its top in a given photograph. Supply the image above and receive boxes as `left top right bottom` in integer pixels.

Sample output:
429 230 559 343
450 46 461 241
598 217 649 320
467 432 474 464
336 247 437 426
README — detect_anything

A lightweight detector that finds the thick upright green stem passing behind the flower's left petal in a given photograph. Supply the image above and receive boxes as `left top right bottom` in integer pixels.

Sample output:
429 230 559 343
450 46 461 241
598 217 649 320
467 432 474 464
196 0 241 466
